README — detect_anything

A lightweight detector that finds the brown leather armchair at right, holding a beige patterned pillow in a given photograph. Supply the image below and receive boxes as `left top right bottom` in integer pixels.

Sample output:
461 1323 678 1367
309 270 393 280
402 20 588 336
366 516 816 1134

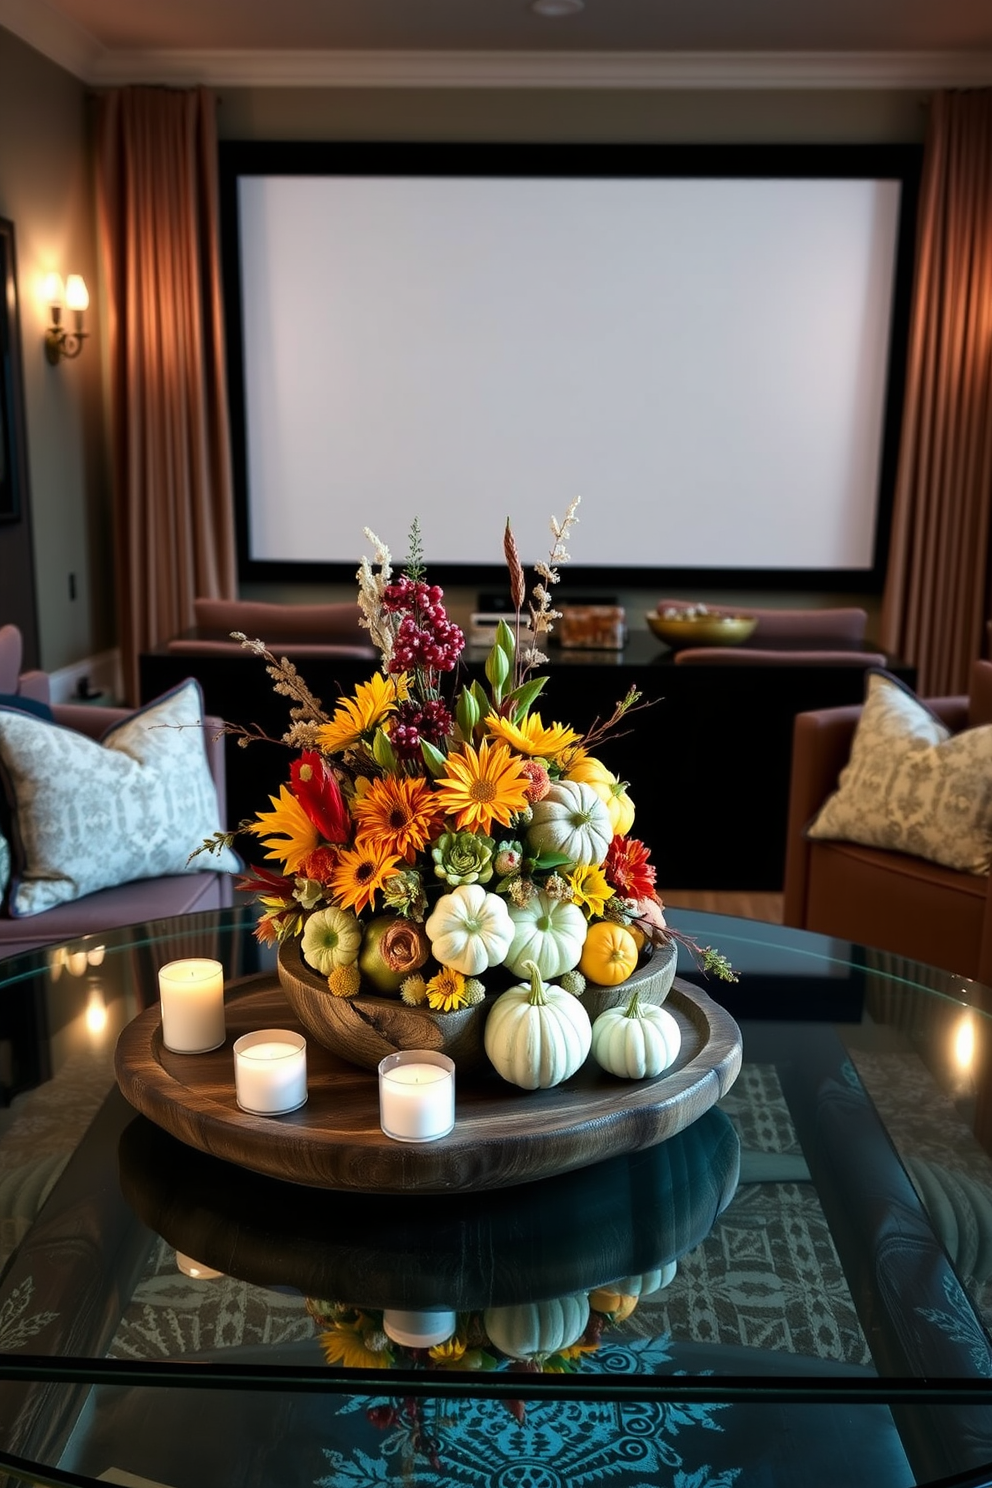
782 661 992 988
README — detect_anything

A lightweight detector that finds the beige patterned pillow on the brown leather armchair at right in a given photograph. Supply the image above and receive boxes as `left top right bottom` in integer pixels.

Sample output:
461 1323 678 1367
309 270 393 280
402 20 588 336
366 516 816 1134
806 673 992 873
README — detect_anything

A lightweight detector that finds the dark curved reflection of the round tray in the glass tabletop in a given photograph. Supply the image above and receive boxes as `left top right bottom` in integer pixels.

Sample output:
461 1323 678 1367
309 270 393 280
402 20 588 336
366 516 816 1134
117 1107 741 1311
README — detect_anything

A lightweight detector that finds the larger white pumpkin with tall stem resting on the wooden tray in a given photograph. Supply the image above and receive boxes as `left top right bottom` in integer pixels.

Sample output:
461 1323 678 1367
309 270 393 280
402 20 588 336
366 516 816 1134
483 961 592 1091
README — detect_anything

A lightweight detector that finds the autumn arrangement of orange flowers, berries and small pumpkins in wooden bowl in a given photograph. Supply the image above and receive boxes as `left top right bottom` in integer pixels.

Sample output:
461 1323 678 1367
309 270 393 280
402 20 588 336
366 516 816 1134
214 501 733 1047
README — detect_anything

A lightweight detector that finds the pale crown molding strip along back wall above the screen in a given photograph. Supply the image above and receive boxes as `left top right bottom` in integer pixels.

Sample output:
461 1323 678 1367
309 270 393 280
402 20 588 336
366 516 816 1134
79 51 992 89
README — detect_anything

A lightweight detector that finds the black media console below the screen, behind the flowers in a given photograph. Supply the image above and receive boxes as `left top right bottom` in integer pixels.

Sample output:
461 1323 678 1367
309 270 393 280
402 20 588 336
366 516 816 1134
141 632 915 891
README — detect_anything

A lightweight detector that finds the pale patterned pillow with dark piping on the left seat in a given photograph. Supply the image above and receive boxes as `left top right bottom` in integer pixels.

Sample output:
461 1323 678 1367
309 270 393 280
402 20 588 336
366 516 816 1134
0 680 241 917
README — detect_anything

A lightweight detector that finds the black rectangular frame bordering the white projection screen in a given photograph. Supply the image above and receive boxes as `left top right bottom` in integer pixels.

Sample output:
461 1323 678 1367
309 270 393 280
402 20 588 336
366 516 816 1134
219 140 922 594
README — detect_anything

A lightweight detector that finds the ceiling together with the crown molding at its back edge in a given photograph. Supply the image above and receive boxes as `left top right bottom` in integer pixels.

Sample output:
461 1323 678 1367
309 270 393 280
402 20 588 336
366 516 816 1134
0 0 992 86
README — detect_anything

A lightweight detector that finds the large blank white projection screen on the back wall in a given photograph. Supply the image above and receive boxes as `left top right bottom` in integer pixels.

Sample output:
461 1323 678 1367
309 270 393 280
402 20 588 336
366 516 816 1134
221 145 922 583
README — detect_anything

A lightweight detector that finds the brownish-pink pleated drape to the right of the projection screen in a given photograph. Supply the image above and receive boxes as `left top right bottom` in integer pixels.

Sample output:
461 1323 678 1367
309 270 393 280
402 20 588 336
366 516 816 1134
880 91 992 696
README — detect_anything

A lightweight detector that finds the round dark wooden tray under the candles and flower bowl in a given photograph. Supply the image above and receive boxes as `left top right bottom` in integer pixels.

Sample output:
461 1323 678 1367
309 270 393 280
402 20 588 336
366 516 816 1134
116 978 741 1193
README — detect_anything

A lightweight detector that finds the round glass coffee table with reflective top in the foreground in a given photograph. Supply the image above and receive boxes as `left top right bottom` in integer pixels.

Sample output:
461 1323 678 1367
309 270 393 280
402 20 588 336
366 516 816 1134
0 909 992 1488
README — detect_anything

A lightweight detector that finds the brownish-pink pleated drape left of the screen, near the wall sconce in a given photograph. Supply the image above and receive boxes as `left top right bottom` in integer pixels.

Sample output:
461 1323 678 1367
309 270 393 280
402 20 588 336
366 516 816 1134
97 88 236 702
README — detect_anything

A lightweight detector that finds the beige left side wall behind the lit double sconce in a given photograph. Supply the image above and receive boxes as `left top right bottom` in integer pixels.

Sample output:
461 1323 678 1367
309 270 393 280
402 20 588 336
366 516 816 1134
0 30 113 670
